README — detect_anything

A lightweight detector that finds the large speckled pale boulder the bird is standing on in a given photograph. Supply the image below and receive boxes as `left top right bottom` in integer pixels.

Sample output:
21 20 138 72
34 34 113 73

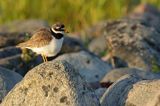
1 61 99 106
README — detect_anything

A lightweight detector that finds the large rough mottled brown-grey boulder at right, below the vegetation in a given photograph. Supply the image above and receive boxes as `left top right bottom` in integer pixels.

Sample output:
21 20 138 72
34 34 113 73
105 18 160 71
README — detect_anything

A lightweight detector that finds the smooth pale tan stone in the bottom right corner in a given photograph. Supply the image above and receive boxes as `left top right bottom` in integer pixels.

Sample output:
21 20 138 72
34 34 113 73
125 79 160 106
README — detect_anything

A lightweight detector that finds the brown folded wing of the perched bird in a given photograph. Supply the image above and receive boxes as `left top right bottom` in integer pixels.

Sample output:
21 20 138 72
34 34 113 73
18 28 52 48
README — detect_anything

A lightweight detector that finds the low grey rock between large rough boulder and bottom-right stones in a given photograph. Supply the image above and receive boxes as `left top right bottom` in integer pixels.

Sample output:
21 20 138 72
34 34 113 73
100 68 160 87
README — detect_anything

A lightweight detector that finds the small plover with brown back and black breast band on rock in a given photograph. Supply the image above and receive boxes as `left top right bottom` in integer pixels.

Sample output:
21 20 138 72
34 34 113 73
16 22 68 62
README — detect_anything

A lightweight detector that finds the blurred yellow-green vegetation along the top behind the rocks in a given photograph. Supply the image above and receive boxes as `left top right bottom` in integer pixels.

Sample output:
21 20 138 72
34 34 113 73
0 0 160 31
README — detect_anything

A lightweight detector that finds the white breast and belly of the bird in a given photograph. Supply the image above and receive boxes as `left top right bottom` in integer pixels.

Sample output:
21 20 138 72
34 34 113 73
29 37 64 57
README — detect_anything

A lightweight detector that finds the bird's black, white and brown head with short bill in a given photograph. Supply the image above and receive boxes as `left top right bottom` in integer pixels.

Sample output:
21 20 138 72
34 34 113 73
51 22 67 34
